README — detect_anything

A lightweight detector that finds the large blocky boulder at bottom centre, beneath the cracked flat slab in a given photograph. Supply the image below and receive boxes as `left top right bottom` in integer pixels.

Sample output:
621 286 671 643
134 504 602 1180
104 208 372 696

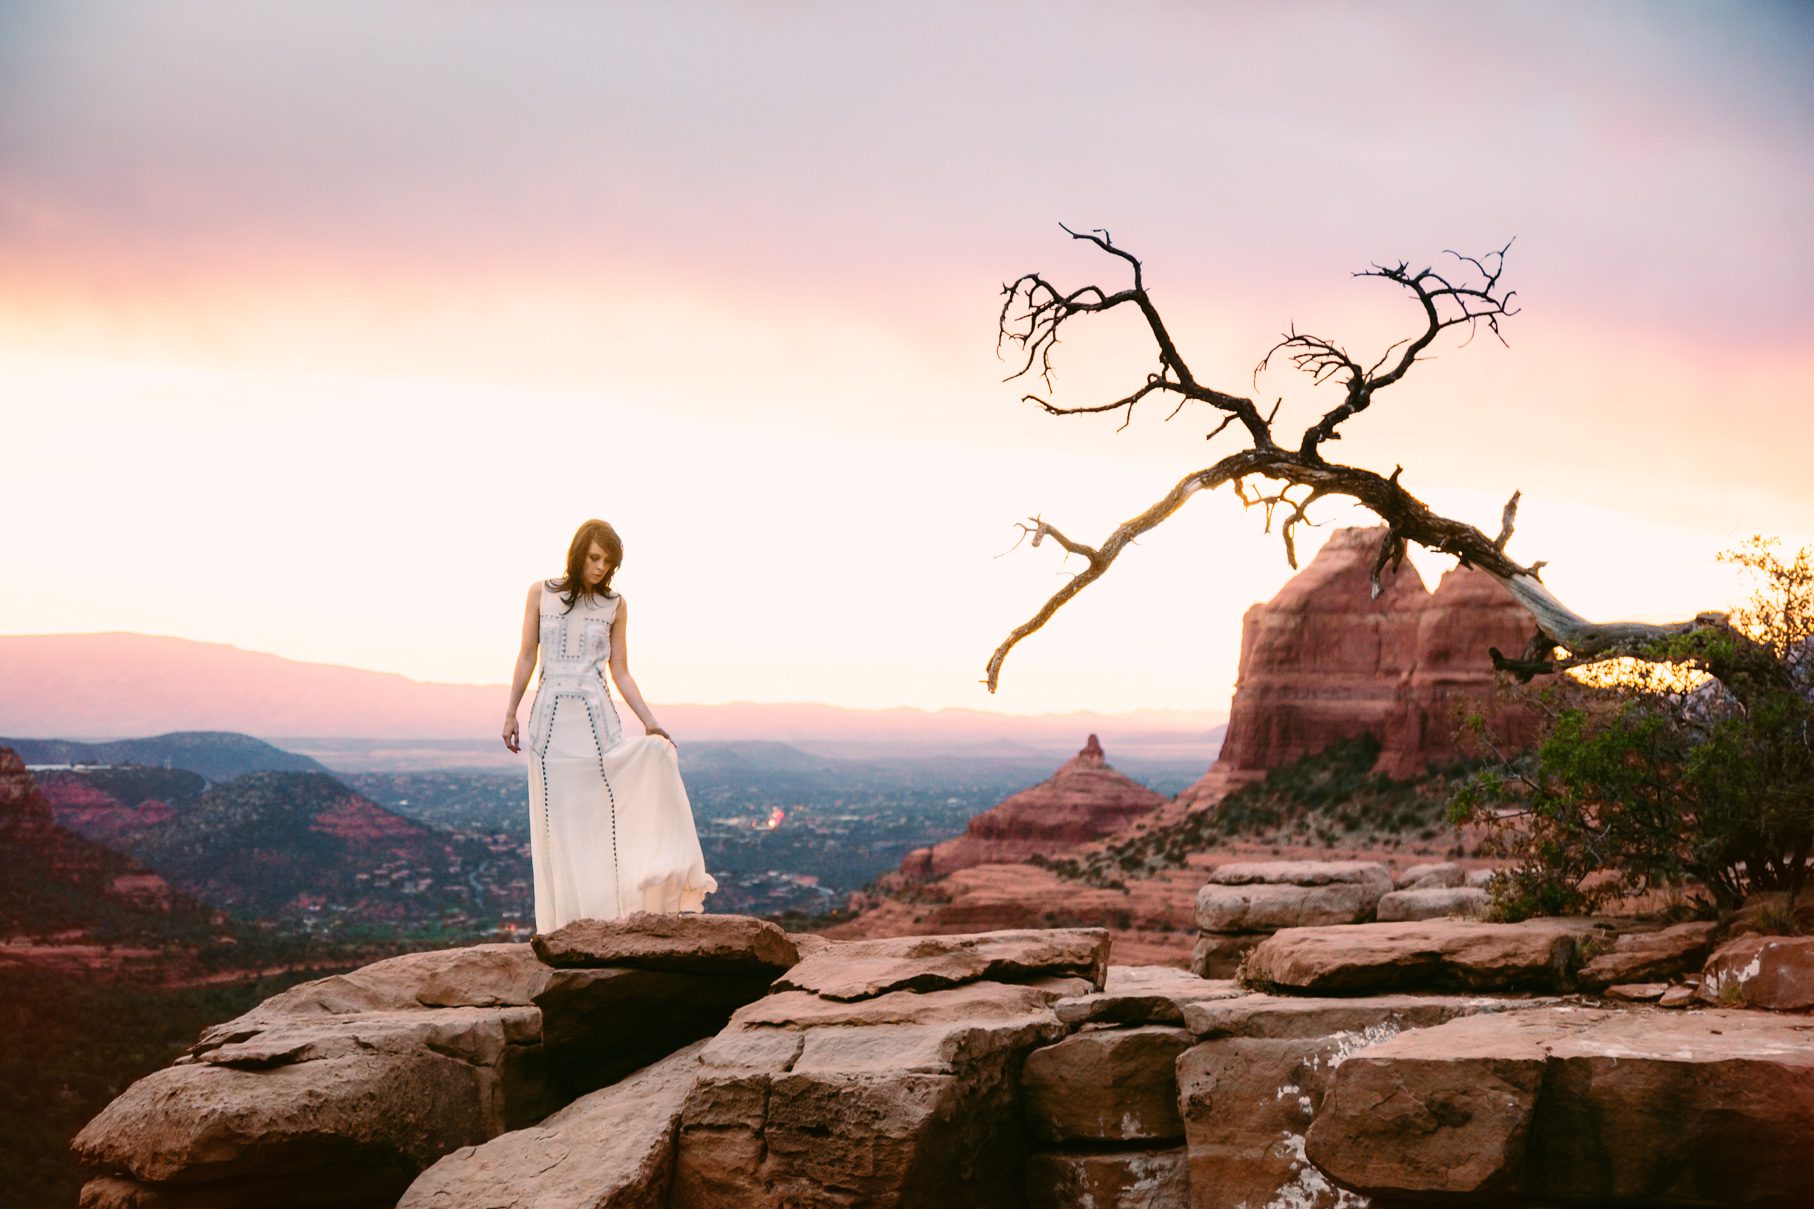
669 973 1059 1209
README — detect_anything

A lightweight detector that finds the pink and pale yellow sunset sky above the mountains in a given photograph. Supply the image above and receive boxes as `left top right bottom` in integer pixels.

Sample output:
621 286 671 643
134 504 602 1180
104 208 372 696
0 0 1814 713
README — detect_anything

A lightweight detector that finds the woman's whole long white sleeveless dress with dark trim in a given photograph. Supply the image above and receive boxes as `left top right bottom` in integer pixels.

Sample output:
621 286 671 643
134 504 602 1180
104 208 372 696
528 581 718 933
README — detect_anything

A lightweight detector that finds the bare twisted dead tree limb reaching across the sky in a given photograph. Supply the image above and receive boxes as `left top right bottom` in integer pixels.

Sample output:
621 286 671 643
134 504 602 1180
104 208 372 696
983 227 1785 699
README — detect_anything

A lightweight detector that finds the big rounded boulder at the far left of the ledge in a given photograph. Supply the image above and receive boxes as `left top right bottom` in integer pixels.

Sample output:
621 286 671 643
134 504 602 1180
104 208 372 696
71 944 551 1205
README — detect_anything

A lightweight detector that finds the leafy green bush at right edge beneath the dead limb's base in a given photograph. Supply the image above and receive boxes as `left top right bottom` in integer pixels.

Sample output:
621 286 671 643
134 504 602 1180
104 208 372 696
1449 537 1814 919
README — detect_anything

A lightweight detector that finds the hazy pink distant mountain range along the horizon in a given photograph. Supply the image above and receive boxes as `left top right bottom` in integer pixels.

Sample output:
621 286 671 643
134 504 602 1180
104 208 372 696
0 632 1226 770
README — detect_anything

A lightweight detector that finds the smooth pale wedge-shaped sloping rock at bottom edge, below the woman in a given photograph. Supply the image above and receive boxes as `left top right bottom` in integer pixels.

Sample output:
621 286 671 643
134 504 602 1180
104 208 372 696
397 1040 706 1209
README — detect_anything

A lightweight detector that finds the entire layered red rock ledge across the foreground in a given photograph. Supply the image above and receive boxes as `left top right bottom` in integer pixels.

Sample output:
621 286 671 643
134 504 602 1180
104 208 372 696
74 907 1814 1209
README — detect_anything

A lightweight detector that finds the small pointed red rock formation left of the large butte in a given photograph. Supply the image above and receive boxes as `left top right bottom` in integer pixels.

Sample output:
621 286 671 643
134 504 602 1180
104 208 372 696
902 735 1166 879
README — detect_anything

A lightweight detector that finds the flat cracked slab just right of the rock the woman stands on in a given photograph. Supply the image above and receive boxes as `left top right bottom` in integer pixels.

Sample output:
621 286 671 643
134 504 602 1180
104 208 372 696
775 928 1108 1000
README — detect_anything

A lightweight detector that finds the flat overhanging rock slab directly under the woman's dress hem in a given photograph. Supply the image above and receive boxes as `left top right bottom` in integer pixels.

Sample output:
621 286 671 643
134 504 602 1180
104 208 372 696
530 911 800 973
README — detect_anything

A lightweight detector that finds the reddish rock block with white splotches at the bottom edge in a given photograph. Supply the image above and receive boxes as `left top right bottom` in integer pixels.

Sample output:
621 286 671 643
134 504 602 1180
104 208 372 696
1177 995 1545 1209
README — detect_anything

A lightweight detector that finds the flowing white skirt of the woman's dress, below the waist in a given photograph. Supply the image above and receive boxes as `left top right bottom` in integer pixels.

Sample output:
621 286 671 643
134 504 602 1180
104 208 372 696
530 693 718 933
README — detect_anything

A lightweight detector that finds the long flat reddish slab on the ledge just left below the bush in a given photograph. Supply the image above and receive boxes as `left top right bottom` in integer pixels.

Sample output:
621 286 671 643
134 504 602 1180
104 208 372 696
1246 919 1600 995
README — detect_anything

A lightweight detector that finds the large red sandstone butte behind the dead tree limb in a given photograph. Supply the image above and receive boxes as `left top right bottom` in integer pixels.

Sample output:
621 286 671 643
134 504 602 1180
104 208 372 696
1179 526 1536 802
